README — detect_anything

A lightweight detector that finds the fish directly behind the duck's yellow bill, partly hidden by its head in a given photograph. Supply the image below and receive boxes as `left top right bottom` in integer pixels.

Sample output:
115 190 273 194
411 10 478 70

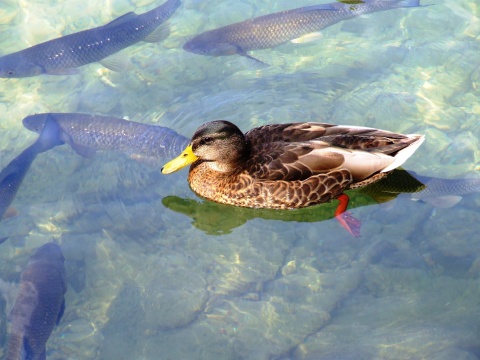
23 113 189 158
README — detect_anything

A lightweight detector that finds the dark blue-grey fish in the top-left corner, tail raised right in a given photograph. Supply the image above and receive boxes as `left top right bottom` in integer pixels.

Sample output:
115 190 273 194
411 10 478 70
0 0 181 78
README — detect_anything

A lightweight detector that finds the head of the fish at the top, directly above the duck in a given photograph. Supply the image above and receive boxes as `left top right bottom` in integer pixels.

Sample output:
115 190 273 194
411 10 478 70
183 32 239 56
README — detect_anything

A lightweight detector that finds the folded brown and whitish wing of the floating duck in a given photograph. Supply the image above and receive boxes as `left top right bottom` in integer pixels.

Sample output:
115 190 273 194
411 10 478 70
245 123 423 182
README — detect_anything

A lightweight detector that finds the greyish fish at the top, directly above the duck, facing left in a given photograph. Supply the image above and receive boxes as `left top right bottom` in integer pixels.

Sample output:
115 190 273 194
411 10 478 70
183 0 421 67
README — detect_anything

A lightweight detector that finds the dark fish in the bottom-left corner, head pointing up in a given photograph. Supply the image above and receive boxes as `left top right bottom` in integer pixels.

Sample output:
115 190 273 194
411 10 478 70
7 243 67 360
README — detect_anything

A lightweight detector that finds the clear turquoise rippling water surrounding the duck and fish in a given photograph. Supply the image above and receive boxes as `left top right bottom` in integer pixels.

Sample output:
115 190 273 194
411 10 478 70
0 0 480 359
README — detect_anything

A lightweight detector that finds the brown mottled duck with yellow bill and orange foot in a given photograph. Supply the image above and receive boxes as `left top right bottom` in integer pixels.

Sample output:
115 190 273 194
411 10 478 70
162 120 425 235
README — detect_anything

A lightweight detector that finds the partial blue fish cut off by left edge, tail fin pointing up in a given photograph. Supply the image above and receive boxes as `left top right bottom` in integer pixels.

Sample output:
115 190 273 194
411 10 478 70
0 116 63 219
